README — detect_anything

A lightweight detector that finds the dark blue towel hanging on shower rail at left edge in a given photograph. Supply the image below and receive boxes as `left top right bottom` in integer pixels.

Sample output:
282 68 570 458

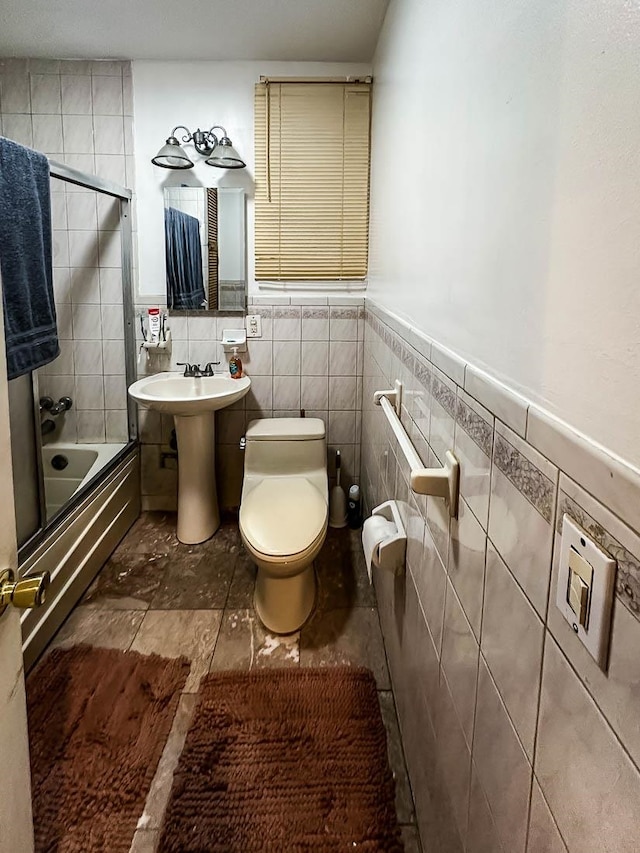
0 137 60 379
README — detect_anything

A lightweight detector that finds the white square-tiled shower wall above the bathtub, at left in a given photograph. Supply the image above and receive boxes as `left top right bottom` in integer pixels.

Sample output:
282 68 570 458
0 59 135 443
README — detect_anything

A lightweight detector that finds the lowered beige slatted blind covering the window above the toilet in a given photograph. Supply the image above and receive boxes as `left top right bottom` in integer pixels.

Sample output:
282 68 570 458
255 82 371 281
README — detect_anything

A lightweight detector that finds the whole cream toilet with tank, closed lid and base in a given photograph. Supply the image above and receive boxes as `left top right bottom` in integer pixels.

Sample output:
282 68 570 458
240 418 329 634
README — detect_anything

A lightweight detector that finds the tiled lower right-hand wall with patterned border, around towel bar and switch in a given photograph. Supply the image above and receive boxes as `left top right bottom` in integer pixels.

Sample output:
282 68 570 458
361 301 640 853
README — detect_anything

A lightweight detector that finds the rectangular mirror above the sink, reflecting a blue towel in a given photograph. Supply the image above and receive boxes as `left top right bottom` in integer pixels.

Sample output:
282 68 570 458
164 187 247 311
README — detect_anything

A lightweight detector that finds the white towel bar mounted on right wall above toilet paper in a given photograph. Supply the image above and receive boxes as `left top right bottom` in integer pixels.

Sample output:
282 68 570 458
373 381 460 518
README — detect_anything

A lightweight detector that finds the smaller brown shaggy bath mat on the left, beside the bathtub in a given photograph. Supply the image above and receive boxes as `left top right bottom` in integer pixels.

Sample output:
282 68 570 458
27 646 189 853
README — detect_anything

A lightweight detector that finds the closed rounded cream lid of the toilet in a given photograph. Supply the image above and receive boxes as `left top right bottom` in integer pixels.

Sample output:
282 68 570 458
240 477 327 557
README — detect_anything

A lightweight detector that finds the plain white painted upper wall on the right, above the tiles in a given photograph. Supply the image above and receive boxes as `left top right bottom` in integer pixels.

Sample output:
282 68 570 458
368 0 640 464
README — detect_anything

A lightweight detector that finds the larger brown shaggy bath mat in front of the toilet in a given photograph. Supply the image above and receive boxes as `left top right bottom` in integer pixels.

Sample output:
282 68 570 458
159 667 403 853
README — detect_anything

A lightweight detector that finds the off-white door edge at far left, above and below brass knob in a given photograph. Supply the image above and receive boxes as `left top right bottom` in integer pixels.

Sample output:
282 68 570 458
0 270 33 853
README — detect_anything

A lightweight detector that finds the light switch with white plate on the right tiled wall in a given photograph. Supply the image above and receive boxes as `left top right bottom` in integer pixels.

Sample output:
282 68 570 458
556 514 616 669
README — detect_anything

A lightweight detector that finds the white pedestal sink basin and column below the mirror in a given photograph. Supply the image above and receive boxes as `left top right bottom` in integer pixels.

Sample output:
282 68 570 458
129 373 251 545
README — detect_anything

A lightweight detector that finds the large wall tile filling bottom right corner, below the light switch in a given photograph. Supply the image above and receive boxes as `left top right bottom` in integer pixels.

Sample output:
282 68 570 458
535 638 640 853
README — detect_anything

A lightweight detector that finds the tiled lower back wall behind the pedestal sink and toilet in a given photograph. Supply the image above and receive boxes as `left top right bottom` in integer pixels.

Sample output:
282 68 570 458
137 297 364 509
